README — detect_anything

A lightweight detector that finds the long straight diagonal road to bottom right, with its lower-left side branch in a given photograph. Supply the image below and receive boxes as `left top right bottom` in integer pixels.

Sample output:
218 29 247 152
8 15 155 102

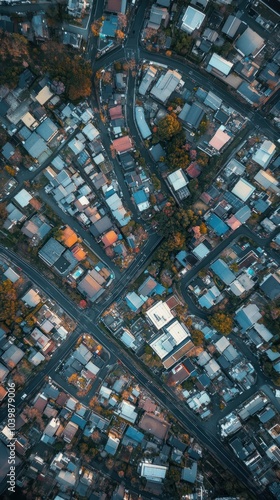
0 241 266 498
